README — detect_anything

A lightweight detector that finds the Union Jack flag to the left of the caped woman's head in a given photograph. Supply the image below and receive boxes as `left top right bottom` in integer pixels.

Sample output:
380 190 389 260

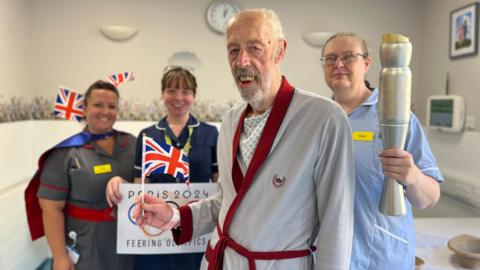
53 86 83 122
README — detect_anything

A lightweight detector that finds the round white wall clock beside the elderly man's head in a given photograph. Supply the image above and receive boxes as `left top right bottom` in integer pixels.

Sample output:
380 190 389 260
207 0 240 34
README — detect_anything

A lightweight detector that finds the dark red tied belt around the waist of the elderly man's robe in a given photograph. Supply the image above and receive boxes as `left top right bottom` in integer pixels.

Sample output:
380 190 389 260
205 224 317 270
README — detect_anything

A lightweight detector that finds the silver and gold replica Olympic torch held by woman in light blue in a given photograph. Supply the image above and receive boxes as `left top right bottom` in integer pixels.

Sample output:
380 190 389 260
378 34 412 216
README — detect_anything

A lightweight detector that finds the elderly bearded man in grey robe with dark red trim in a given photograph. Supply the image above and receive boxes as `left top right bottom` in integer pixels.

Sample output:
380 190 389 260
134 9 354 269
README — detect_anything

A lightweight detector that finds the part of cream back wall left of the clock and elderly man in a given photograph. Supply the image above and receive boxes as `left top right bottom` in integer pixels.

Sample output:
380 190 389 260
30 0 237 101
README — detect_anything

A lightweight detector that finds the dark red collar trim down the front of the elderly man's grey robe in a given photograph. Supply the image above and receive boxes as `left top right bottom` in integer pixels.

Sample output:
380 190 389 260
208 77 295 270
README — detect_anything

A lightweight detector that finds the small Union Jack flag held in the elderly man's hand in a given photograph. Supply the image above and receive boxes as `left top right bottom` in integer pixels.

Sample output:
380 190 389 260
143 136 190 185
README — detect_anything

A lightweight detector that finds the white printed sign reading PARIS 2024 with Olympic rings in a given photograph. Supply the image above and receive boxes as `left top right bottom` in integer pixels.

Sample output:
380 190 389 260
117 183 218 254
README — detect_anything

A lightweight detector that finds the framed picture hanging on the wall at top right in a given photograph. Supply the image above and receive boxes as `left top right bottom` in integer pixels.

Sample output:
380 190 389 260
450 3 479 59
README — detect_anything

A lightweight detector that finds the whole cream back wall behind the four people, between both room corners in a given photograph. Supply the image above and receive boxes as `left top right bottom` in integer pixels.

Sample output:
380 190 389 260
28 0 420 102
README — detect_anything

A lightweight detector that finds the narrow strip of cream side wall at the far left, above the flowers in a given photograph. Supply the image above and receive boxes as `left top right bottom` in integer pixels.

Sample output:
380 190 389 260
0 0 31 98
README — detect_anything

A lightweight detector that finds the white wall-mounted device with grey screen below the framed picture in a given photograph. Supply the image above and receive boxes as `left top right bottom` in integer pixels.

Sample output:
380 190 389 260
427 95 465 132
